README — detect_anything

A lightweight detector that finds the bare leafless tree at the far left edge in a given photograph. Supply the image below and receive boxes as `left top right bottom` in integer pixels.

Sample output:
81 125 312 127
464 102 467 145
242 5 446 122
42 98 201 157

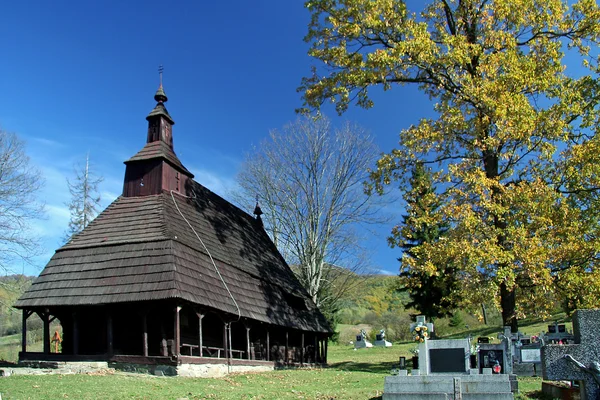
0 129 44 273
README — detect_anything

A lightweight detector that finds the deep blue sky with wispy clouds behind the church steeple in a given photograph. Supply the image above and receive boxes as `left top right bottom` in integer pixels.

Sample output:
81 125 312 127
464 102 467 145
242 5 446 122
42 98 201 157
0 0 431 274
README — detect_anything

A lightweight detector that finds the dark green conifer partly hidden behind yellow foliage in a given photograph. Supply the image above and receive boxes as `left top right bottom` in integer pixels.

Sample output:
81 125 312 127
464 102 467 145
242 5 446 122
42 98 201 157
388 163 460 320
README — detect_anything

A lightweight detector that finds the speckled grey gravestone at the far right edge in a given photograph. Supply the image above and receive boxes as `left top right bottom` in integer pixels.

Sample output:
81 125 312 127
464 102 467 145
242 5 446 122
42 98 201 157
541 310 600 400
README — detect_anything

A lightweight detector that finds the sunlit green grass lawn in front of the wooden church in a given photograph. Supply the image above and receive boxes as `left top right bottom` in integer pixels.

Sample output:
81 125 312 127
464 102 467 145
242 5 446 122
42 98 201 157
0 343 542 400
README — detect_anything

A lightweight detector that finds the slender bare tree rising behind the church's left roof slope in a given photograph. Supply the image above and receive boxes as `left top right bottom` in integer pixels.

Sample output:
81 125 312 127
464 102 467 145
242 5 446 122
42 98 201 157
65 155 103 241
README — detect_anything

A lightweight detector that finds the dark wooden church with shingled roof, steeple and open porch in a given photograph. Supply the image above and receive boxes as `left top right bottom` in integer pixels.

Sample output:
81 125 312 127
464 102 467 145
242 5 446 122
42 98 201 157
15 79 332 376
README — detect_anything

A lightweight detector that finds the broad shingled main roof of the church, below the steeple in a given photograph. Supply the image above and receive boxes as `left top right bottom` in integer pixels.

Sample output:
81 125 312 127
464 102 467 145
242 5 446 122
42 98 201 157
15 182 330 332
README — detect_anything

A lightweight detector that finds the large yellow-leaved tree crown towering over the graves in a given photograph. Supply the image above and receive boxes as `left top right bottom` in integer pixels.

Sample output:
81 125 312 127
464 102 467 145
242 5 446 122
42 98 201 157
300 0 600 330
